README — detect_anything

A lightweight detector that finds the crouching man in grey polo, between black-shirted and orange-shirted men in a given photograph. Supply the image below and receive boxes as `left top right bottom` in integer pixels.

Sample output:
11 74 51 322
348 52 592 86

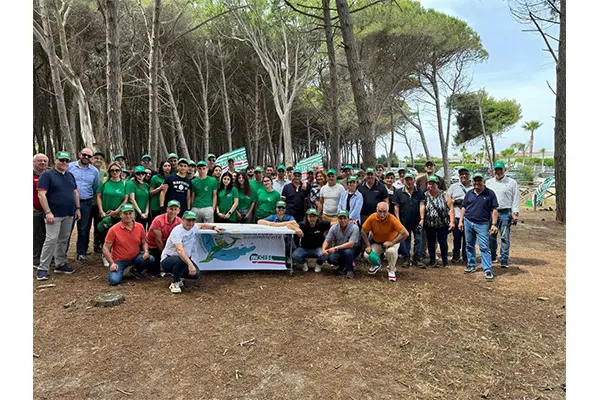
322 210 360 279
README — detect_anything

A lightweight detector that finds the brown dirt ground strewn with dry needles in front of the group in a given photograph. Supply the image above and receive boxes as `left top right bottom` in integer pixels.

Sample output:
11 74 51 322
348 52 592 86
33 211 566 400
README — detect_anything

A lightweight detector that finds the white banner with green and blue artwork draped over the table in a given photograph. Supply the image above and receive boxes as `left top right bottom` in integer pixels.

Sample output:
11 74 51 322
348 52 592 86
191 224 294 271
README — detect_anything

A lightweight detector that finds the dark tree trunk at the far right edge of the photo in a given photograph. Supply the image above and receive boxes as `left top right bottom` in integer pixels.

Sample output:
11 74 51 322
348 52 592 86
554 0 567 223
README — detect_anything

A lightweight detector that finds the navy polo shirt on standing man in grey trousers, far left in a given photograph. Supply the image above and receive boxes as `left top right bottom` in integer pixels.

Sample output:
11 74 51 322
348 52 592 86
37 168 77 217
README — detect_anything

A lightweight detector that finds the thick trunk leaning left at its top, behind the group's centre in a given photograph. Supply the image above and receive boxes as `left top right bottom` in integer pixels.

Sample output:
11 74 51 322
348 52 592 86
335 0 377 165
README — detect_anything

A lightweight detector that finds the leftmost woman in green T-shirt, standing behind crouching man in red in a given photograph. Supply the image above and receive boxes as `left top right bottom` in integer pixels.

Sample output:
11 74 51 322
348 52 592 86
96 161 129 267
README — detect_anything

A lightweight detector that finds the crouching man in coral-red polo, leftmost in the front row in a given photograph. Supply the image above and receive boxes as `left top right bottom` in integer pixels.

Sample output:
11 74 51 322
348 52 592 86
102 203 154 285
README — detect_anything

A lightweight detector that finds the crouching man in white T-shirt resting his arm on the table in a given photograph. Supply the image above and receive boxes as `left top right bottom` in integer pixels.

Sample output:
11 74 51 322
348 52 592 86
160 211 225 293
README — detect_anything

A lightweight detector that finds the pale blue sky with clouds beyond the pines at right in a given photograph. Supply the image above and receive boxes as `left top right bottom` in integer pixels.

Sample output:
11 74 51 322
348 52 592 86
377 0 556 159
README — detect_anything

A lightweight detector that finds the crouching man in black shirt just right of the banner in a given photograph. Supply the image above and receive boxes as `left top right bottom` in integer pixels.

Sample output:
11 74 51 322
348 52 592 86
292 208 331 272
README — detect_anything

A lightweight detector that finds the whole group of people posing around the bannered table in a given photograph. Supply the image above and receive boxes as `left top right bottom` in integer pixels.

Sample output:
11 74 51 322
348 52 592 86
33 148 520 293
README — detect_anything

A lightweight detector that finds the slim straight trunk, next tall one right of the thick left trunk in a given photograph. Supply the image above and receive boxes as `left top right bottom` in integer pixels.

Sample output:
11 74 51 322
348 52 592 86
148 0 161 162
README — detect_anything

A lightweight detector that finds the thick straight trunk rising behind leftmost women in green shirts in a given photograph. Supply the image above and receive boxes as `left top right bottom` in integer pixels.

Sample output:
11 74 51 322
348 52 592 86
105 0 123 155
